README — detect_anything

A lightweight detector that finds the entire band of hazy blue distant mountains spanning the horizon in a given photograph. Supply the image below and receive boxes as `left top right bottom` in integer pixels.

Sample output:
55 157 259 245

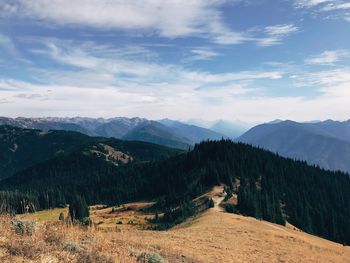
0 117 350 172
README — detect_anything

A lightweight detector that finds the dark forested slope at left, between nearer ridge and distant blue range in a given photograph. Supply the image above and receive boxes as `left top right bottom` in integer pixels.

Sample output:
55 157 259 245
0 126 179 182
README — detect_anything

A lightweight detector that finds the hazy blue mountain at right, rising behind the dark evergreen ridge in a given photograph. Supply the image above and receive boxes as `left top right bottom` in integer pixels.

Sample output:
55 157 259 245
237 121 350 172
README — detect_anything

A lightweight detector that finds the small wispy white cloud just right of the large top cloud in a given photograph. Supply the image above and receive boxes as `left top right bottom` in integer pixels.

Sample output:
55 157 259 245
258 24 299 46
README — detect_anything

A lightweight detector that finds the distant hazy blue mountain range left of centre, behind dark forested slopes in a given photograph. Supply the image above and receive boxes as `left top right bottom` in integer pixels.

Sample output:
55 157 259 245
0 117 229 149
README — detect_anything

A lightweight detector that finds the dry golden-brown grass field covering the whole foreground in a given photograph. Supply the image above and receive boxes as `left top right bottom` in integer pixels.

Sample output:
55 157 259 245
0 189 350 263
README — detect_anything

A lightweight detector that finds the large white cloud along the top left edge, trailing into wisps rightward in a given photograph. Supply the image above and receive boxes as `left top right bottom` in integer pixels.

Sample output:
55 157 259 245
0 0 297 45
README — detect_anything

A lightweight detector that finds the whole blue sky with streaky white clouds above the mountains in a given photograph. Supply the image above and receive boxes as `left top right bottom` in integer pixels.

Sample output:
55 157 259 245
0 0 350 123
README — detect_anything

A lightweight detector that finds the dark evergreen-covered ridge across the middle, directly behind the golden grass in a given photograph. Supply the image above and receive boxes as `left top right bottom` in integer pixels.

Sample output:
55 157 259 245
0 140 350 244
